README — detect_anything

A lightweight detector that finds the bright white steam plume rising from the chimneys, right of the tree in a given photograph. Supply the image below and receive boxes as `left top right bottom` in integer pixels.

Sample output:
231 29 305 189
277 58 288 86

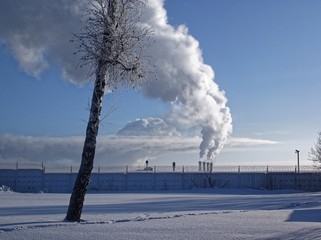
143 0 232 159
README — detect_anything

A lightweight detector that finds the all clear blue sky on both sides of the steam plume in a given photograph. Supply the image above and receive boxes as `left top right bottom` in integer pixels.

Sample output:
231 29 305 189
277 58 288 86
0 0 321 165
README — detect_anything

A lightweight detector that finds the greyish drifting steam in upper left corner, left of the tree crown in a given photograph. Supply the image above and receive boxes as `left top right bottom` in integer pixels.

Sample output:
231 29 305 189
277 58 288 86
0 0 88 83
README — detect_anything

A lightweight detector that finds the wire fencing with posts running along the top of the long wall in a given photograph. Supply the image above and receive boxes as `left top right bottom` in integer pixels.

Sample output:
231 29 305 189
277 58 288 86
0 162 321 173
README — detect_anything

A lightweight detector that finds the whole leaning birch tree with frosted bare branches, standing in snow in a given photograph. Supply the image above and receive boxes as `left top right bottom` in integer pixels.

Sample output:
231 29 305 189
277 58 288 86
66 0 151 222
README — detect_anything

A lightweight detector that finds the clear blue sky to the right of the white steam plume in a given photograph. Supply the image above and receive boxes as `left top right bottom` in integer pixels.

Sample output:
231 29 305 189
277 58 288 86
166 1 321 164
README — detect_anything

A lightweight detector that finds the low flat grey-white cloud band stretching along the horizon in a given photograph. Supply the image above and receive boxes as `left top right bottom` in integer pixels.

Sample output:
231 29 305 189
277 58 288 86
0 135 276 166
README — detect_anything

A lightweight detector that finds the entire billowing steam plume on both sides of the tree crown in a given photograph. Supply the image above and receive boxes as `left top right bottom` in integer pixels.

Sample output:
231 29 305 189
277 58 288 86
0 0 232 159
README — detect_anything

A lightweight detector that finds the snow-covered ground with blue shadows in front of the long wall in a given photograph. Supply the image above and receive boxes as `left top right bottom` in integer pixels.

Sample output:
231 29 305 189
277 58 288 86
0 189 321 240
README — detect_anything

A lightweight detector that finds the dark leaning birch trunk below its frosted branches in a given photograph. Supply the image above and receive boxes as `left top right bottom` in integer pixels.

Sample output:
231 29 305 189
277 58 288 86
65 61 106 222
